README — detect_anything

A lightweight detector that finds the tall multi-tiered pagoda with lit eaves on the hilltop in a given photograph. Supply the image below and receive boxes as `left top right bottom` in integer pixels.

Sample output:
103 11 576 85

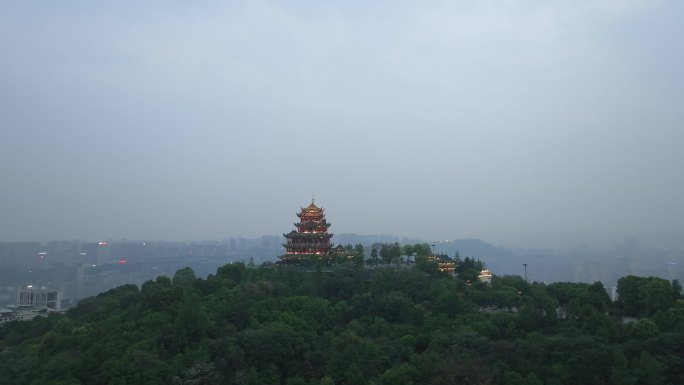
278 198 333 265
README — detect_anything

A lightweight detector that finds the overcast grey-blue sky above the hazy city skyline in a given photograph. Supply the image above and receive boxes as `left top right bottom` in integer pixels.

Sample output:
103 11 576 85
0 0 684 243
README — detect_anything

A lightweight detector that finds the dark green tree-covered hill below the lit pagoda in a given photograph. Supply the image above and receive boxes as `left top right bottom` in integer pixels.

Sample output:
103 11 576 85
0 264 684 385
